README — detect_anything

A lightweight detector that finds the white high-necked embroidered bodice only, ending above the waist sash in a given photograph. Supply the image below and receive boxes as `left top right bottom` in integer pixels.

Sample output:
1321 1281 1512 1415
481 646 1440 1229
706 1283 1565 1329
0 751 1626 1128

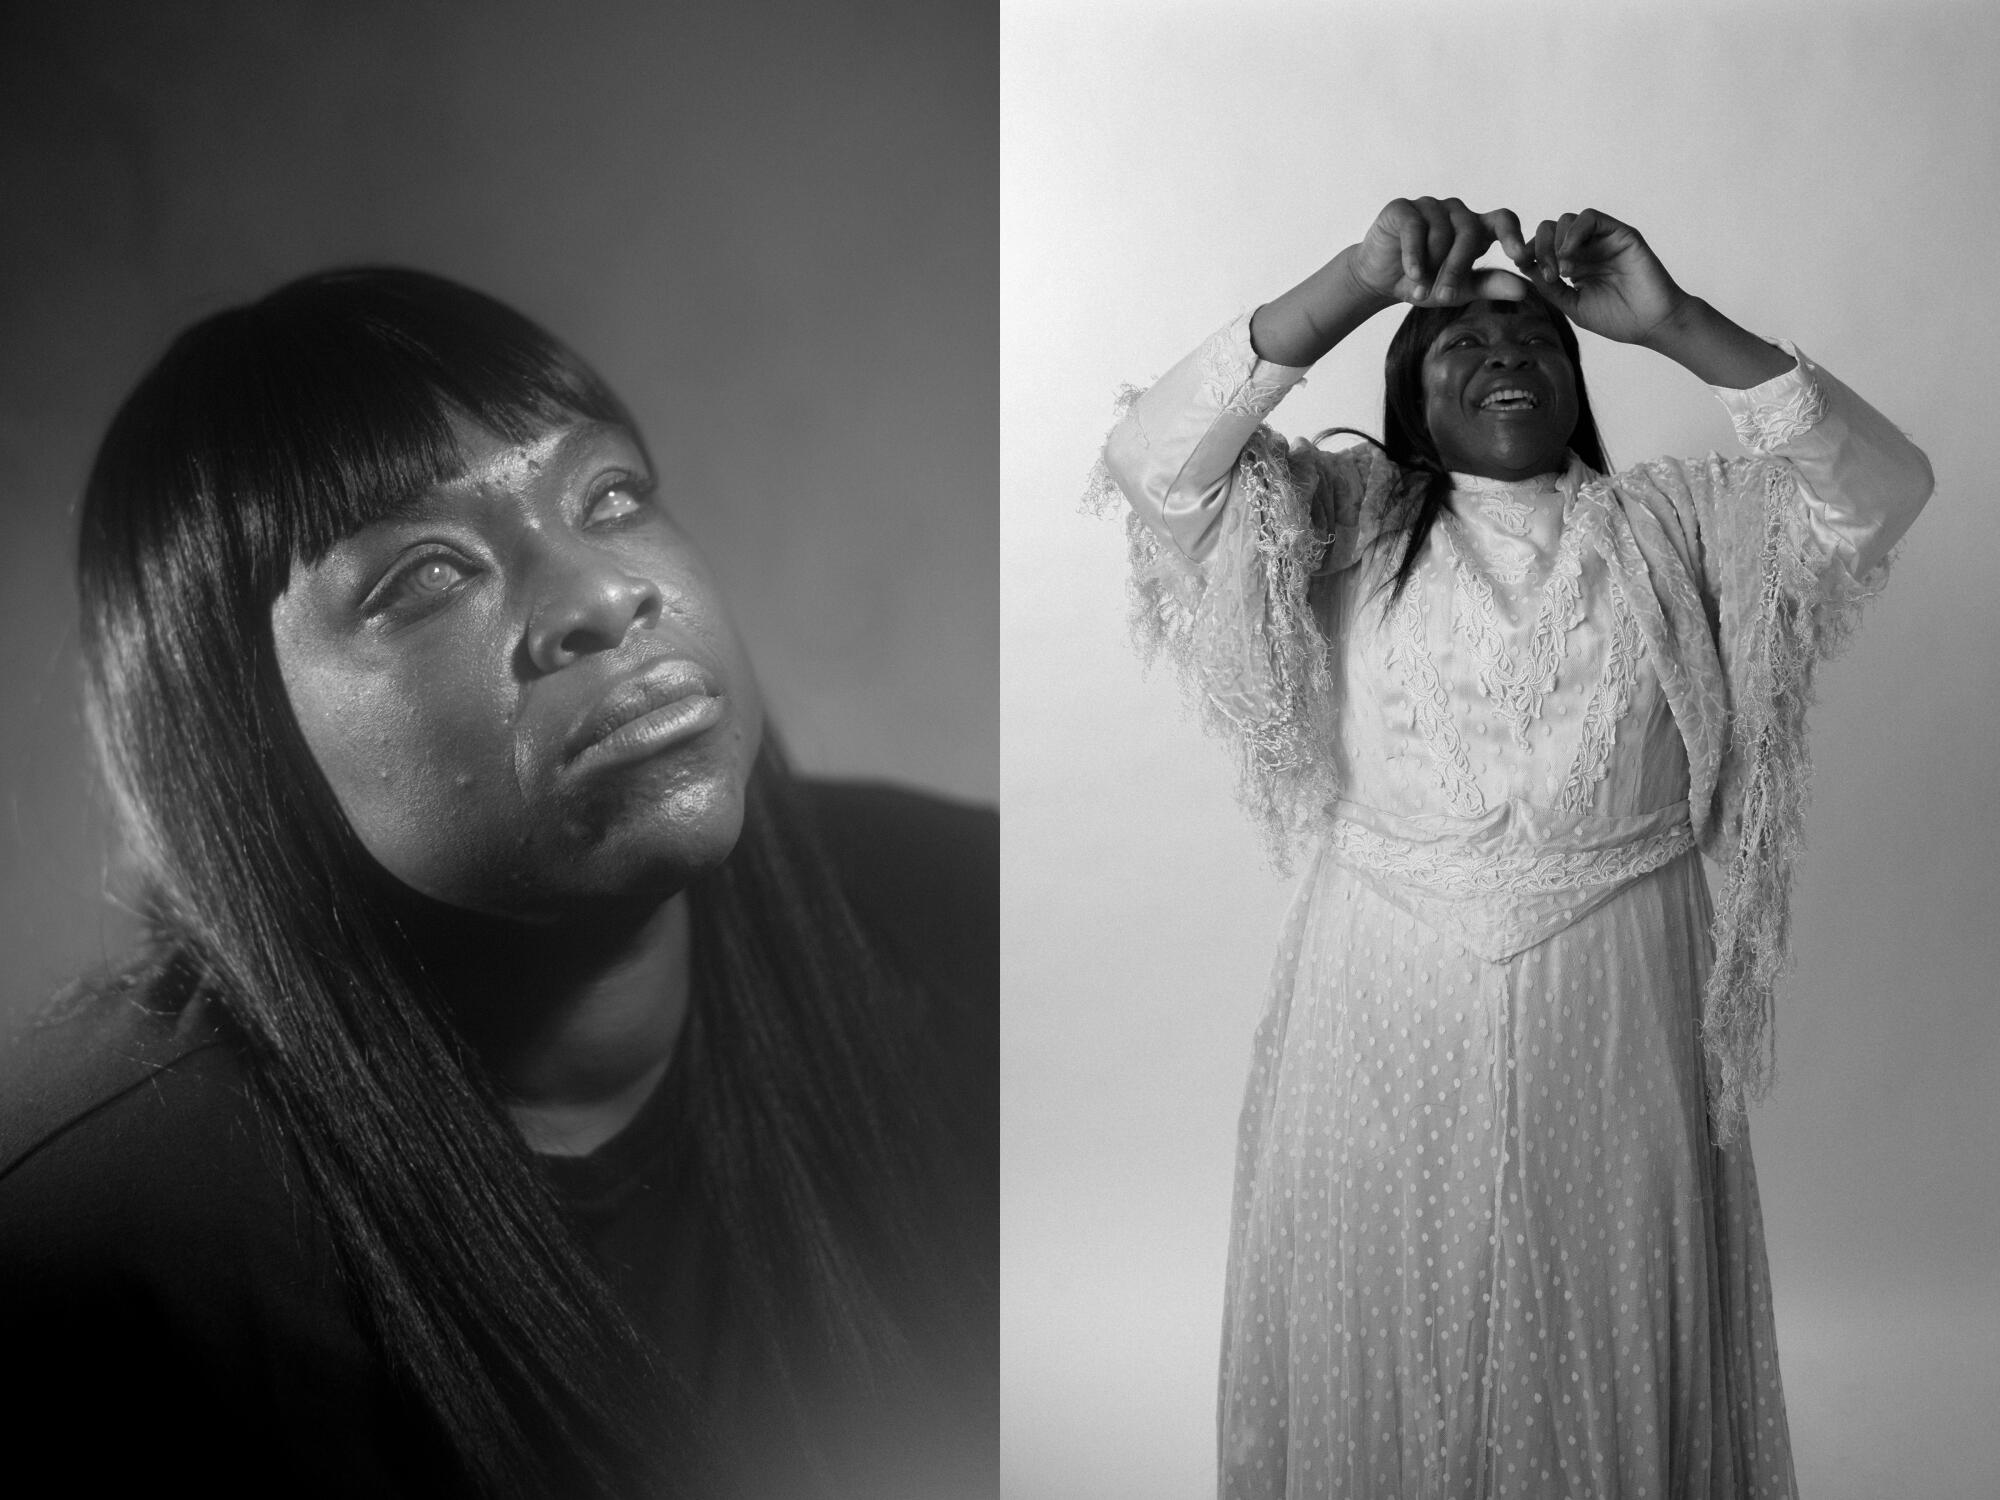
1324 466 1688 818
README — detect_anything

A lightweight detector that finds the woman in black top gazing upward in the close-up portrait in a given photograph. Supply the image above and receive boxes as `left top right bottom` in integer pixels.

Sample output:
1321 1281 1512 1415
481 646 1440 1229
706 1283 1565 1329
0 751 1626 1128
0 270 996 1496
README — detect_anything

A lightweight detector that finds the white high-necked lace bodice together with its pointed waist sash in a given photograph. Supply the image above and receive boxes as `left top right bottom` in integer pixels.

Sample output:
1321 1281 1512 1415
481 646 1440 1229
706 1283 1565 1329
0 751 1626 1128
1316 458 1692 960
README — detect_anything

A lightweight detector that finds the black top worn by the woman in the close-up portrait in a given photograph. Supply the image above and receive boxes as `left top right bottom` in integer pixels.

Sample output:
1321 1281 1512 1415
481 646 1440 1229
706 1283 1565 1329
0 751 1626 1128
0 784 998 1496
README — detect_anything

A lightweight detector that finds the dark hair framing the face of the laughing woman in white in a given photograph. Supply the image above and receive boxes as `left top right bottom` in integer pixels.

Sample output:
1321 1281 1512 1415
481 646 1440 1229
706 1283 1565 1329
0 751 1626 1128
1320 282 1610 604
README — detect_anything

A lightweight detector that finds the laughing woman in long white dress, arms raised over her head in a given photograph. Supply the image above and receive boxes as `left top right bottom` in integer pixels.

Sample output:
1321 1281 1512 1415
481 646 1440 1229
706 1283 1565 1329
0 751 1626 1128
1106 198 1930 1500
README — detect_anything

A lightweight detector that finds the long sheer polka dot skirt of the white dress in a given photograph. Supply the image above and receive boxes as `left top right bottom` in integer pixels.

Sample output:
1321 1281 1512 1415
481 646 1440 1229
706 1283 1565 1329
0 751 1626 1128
1220 854 1794 1500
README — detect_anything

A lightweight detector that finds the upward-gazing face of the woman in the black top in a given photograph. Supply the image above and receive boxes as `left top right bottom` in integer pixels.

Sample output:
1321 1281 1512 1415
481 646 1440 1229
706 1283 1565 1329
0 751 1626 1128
272 422 762 920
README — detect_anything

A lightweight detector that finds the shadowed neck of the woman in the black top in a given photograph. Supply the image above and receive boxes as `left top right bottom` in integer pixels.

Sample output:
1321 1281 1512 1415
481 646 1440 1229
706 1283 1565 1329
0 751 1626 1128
410 892 690 1156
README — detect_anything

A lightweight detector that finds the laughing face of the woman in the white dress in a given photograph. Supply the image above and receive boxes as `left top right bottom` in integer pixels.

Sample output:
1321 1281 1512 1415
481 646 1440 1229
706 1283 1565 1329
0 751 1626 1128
1424 300 1578 480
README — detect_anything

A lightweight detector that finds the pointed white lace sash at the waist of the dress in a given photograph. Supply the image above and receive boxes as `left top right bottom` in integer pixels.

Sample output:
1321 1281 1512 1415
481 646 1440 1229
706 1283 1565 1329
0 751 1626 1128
1326 800 1694 964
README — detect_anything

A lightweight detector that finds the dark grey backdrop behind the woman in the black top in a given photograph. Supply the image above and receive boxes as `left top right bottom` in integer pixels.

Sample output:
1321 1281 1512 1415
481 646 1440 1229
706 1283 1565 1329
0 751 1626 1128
0 0 998 1014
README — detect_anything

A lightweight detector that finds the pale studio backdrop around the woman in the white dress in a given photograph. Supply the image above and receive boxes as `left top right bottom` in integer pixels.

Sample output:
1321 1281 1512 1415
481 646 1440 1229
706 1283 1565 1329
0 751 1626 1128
1000 0 2000 1500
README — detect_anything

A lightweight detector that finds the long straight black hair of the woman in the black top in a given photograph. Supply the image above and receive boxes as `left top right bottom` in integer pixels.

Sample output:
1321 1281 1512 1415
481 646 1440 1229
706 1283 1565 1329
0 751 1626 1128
78 268 984 1496
